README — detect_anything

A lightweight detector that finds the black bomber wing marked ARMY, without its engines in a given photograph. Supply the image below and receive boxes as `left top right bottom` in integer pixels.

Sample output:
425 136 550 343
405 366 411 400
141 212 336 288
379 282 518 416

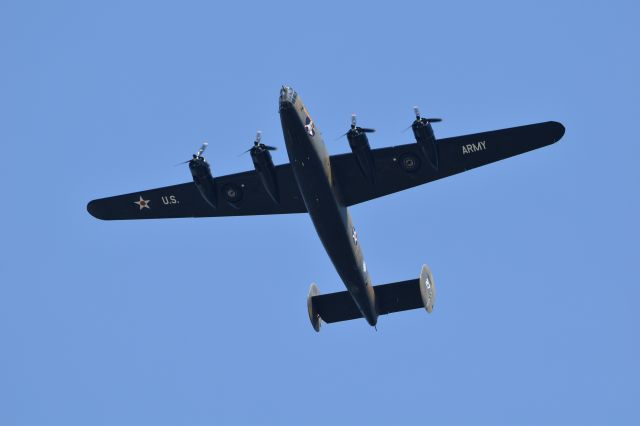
331 121 564 206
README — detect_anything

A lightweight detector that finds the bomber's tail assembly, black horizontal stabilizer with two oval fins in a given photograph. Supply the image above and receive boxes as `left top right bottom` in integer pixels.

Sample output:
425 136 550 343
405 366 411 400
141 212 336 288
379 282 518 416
308 265 435 331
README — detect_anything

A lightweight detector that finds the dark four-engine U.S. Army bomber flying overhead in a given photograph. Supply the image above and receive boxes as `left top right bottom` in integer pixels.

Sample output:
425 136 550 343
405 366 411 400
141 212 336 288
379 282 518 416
87 86 565 331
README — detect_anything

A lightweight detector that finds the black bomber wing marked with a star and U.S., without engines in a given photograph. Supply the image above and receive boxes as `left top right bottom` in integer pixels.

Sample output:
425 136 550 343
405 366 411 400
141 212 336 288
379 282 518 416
87 164 307 220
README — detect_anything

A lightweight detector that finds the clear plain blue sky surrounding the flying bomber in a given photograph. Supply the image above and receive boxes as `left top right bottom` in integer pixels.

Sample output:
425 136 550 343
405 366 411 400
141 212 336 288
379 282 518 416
0 0 640 425
